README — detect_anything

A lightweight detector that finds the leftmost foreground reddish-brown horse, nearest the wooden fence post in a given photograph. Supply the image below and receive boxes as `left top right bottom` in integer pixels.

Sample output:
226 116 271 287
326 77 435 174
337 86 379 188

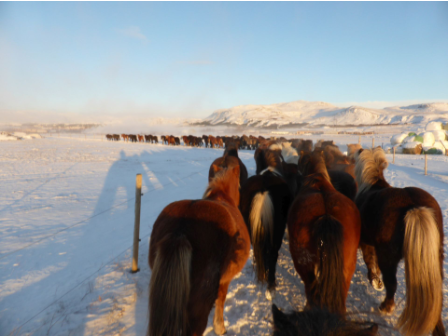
148 166 250 336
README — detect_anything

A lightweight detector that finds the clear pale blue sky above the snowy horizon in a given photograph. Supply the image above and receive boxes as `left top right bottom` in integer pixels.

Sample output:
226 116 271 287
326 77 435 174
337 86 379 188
0 2 448 121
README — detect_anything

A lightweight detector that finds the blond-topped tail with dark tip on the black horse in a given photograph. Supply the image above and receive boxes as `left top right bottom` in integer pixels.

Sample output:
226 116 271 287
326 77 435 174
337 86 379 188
249 191 274 283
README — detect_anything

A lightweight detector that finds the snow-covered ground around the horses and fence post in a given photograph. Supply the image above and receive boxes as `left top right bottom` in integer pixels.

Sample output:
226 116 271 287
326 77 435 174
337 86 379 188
0 136 448 336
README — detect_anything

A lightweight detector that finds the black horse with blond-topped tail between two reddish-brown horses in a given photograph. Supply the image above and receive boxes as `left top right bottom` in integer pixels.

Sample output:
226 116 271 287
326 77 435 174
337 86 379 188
240 150 292 299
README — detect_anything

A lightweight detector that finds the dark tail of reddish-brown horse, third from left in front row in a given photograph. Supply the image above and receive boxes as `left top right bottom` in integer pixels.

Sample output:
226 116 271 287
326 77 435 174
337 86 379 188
310 215 345 314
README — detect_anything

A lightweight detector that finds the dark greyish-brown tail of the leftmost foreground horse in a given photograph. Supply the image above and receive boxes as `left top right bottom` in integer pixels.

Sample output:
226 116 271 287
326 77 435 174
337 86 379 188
148 235 193 336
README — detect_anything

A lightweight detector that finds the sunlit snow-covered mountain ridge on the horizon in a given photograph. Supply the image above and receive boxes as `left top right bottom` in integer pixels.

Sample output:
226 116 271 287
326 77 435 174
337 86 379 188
200 100 448 128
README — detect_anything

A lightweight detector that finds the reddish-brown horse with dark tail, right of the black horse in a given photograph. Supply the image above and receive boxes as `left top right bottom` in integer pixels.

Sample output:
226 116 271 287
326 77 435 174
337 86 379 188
288 174 361 314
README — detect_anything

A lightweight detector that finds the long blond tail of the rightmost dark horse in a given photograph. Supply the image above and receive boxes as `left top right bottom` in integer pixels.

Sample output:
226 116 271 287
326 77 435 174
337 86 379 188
398 207 442 336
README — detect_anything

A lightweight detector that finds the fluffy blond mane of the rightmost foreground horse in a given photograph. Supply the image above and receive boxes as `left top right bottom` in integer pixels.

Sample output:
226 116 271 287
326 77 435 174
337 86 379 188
355 147 388 195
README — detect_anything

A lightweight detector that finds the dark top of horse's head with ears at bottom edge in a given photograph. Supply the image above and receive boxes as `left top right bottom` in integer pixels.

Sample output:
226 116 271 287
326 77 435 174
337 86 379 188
272 305 378 336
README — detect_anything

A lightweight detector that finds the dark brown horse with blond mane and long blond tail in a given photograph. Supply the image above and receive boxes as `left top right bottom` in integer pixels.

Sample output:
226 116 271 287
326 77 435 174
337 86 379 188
355 147 445 336
